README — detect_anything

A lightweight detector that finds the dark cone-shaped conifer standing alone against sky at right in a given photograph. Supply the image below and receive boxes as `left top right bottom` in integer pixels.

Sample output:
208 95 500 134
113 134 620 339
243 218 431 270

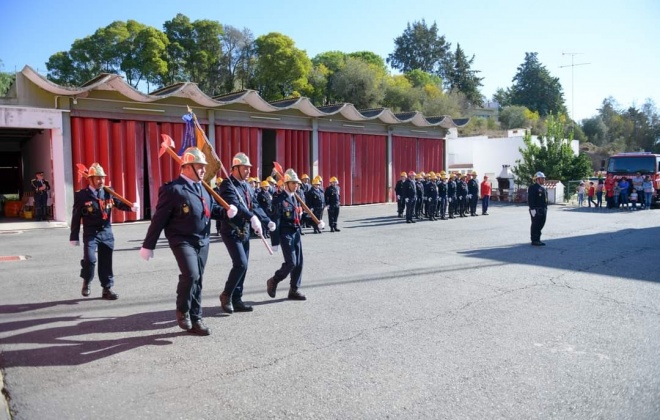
510 52 566 117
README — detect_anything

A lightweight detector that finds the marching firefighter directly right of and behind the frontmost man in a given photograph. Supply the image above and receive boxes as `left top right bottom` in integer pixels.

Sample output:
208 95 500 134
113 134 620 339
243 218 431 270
220 153 275 314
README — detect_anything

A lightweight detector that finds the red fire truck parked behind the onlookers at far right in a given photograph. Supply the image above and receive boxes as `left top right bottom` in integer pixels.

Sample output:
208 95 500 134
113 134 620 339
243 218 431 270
607 152 660 206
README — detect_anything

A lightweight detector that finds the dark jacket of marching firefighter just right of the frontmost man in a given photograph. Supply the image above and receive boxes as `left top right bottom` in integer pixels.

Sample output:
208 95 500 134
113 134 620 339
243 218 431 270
220 175 270 238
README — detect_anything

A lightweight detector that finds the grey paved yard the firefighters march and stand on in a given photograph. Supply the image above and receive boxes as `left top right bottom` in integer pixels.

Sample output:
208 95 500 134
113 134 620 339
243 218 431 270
0 205 660 419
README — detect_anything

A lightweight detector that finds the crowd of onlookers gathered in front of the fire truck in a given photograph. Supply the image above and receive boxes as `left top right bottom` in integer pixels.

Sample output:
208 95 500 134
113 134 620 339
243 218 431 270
577 172 654 211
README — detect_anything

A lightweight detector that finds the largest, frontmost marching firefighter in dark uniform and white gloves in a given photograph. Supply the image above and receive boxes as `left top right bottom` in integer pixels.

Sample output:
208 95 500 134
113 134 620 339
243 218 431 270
140 147 237 335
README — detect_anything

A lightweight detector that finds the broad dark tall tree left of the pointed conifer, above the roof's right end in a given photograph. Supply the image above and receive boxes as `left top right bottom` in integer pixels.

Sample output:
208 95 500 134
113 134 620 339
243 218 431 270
387 19 451 76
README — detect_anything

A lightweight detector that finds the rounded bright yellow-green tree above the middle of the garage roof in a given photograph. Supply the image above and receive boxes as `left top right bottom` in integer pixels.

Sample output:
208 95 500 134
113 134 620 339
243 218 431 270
254 32 312 101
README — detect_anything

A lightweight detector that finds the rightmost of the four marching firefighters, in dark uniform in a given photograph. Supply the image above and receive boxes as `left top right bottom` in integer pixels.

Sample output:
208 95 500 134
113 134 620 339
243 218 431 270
266 169 325 300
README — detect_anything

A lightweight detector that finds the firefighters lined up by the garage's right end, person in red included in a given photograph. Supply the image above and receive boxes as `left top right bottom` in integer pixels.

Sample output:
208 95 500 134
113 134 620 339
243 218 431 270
394 171 491 223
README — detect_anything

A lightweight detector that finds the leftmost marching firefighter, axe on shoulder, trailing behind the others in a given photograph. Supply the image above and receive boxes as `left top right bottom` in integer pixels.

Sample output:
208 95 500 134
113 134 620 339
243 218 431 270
69 163 138 300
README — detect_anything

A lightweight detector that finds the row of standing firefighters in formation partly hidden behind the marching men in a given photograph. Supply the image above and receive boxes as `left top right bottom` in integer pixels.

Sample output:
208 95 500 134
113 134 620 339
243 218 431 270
215 174 341 238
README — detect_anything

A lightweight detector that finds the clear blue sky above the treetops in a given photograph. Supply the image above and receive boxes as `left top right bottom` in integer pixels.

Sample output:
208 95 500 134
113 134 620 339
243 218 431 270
0 0 660 120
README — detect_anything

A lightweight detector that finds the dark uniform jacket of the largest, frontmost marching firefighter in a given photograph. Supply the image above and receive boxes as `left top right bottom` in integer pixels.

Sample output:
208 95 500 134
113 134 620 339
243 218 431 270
142 176 225 249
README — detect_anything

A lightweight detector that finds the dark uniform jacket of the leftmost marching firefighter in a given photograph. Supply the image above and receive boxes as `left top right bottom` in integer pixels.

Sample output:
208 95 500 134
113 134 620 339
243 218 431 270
69 188 131 244
